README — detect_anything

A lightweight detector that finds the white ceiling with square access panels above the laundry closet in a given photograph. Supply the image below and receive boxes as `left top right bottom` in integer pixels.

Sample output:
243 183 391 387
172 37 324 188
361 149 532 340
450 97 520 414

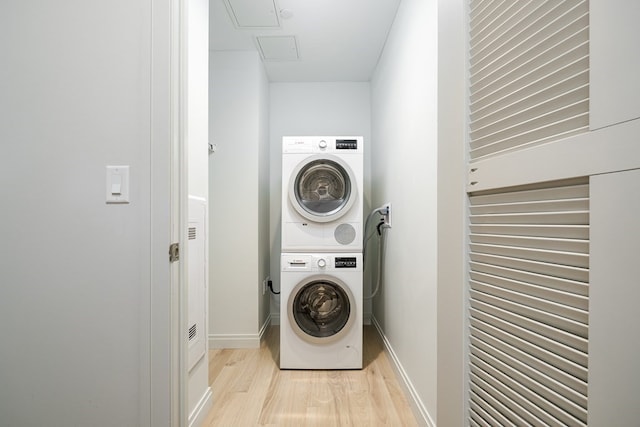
210 0 400 82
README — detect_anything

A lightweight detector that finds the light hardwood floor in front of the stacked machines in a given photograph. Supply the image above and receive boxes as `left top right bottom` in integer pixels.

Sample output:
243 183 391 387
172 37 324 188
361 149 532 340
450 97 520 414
203 326 418 427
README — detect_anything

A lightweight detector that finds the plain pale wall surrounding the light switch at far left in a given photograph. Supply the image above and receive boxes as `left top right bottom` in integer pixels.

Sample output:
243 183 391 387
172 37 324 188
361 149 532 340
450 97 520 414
0 0 170 426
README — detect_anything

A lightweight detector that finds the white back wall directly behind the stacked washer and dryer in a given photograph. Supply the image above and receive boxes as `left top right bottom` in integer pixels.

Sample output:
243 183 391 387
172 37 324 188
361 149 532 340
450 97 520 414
270 82 372 318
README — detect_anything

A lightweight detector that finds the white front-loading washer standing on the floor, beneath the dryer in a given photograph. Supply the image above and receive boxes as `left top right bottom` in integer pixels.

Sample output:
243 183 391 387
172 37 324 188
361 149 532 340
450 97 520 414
280 253 363 369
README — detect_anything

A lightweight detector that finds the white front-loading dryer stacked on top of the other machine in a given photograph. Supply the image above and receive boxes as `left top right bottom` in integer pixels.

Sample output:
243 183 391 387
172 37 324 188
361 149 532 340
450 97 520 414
282 136 364 253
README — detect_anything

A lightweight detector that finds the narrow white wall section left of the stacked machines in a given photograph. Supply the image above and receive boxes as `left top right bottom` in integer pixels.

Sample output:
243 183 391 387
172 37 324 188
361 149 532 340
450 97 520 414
209 51 269 346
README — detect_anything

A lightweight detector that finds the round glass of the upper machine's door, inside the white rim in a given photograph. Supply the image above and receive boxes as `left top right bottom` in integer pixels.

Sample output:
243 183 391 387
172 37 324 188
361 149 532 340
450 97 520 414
294 159 351 221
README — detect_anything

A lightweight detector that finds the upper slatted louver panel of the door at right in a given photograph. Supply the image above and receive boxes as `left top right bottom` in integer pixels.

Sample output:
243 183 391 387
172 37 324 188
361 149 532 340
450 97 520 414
469 0 589 160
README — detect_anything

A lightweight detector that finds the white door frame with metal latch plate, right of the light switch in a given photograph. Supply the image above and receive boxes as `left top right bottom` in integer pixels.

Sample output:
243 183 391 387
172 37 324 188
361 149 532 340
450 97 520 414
149 0 188 427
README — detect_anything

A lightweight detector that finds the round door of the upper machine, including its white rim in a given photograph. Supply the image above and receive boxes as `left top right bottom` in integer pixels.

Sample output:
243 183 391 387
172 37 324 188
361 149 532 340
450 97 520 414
289 155 357 222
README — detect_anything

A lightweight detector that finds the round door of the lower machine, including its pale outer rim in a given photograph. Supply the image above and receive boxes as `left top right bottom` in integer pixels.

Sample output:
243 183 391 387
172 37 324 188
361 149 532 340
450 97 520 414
287 275 356 343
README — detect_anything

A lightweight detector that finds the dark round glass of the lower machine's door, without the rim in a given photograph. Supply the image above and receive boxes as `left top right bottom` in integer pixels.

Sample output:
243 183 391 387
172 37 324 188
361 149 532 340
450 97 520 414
291 280 351 338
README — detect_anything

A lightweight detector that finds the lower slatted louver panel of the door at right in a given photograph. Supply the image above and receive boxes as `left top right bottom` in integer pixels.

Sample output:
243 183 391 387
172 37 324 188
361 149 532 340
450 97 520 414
469 179 589 426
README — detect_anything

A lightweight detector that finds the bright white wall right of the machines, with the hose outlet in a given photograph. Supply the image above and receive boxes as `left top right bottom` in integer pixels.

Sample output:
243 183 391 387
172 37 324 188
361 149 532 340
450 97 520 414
371 0 438 422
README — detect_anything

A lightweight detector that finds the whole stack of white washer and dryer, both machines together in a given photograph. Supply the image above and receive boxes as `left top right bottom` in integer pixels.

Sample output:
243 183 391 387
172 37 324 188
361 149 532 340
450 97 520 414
280 136 364 369
